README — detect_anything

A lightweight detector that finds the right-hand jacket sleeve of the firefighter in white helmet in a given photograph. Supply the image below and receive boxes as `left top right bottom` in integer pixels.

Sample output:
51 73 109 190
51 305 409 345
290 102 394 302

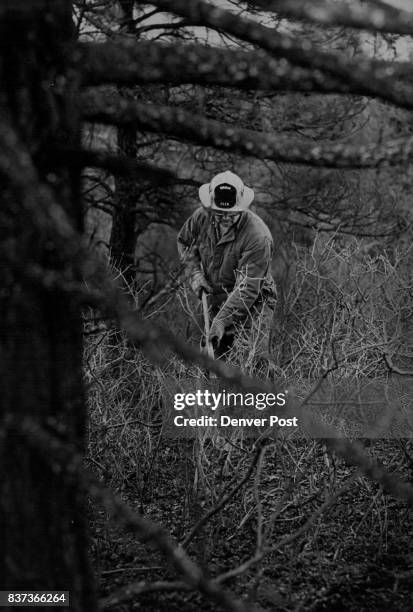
216 236 273 327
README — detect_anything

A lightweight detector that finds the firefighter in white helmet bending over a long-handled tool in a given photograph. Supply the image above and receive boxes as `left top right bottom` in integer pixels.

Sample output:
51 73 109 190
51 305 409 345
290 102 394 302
178 171 276 358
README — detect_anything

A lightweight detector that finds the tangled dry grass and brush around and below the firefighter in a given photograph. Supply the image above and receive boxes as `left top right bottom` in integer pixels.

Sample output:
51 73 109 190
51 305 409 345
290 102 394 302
85 238 413 611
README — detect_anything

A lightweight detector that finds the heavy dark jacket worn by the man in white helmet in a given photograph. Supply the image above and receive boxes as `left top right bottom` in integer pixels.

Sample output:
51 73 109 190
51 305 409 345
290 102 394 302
178 207 276 327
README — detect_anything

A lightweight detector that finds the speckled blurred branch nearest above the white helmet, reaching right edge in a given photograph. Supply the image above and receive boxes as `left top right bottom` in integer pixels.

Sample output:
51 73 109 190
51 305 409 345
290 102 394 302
82 91 413 168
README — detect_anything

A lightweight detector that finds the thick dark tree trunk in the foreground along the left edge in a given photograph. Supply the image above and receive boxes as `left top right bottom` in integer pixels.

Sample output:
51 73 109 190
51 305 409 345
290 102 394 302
0 0 97 611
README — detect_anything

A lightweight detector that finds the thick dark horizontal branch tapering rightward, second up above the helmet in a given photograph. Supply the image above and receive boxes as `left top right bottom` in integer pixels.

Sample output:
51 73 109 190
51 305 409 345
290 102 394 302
74 41 358 93
